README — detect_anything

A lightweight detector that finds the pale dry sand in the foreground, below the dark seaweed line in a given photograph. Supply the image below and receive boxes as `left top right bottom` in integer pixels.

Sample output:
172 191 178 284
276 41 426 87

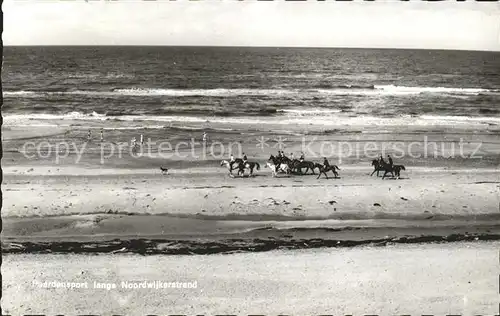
2 242 500 316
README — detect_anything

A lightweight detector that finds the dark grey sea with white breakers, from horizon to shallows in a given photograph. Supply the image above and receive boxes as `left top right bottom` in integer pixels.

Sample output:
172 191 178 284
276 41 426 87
2 46 500 127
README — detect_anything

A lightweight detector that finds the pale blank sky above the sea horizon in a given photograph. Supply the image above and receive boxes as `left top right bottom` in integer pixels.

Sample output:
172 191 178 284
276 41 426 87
3 0 500 51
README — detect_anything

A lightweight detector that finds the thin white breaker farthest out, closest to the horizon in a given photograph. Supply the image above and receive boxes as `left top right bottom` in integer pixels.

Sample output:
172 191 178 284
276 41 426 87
4 83 500 97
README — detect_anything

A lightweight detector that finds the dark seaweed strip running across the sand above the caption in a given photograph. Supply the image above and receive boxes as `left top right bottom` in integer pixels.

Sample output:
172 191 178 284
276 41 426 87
2 234 500 255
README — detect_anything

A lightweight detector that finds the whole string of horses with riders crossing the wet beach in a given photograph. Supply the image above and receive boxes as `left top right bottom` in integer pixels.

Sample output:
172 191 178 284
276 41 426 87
221 155 406 179
